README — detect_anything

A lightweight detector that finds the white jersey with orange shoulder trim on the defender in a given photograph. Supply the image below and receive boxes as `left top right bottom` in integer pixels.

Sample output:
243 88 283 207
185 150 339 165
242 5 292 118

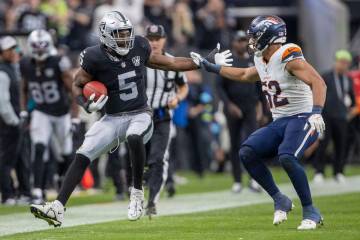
254 43 313 120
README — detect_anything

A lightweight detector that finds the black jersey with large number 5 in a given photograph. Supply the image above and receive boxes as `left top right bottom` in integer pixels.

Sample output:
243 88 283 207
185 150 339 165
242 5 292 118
80 36 151 114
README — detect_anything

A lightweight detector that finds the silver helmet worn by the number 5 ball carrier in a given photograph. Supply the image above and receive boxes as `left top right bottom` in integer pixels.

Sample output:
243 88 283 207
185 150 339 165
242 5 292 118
99 11 135 56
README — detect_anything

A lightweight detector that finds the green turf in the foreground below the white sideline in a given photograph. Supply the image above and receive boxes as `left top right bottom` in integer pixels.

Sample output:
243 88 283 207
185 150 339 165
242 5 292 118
3 193 360 240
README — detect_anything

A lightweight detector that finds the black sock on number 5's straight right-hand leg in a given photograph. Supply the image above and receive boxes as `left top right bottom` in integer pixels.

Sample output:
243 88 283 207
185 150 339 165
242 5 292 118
127 135 146 189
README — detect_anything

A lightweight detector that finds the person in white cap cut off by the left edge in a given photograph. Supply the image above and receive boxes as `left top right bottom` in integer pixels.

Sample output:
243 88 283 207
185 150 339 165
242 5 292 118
0 36 20 205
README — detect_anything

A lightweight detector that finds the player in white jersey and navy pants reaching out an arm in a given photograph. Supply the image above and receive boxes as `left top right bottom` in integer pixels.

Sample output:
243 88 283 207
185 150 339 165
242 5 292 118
191 16 326 230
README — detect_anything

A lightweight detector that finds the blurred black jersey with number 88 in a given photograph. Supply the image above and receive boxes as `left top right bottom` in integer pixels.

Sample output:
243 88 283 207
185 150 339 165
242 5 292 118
20 56 71 116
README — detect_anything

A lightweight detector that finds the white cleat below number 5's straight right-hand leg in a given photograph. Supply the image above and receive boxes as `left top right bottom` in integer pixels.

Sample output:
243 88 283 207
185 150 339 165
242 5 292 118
128 188 144 221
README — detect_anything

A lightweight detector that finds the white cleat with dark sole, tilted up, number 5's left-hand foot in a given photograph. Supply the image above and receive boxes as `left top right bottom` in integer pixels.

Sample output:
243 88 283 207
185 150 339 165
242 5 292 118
30 200 65 227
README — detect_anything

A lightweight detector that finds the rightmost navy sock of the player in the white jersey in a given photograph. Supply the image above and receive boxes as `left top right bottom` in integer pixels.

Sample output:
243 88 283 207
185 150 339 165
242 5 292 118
279 154 312 207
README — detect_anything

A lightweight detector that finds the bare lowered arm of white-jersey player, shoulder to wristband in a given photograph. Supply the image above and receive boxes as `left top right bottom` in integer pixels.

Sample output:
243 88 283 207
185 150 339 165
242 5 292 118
286 59 326 107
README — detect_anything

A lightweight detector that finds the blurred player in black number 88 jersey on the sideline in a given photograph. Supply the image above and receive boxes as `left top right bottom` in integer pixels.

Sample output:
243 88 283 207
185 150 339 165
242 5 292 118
20 30 77 204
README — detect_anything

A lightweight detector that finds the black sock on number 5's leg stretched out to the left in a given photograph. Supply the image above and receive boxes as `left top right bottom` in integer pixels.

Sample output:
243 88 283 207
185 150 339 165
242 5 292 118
57 154 90 206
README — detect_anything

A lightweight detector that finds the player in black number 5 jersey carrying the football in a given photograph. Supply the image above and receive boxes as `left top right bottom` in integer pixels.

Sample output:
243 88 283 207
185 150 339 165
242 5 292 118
30 11 229 226
